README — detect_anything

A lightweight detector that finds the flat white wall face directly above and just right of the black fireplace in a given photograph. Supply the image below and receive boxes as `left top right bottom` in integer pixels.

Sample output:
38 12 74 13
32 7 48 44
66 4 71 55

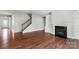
53 10 73 38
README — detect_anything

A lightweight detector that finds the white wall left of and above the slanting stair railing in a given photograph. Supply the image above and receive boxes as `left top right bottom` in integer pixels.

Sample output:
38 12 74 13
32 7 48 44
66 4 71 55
13 13 29 32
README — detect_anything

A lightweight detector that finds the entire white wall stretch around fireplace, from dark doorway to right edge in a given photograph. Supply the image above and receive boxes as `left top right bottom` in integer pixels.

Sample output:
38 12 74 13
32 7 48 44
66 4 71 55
45 10 79 39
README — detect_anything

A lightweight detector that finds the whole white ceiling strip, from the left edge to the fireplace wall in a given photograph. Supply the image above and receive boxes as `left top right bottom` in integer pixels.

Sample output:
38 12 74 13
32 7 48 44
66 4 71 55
0 10 52 16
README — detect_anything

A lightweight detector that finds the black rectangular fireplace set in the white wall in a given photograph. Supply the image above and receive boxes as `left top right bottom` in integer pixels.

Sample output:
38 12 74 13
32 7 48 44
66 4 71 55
55 26 67 38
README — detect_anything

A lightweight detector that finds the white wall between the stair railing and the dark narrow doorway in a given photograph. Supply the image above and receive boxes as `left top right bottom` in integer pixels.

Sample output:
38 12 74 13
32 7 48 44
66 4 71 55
24 14 44 33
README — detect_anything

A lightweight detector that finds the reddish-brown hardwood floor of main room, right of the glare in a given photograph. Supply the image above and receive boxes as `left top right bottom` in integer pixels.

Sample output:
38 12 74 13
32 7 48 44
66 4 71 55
0 31 79 49
